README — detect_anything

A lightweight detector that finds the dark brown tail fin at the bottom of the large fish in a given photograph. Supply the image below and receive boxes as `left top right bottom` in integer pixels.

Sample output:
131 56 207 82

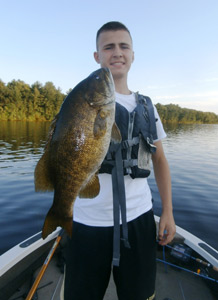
42 207 73 239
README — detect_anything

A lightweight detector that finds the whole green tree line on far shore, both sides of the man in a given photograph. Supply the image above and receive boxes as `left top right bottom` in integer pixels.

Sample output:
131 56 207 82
0 80 218 124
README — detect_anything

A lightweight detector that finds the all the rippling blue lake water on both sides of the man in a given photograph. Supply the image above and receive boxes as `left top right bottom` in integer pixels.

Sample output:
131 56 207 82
0 121 218 254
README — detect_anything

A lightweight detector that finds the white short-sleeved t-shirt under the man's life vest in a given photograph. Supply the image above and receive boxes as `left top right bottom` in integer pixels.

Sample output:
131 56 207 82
73 93 166 227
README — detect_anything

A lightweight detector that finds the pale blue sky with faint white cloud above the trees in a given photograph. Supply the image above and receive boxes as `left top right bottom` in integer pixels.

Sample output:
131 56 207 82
0 0 218 114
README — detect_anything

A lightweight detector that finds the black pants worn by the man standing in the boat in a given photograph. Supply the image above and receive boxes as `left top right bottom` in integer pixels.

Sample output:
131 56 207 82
64 210 156 300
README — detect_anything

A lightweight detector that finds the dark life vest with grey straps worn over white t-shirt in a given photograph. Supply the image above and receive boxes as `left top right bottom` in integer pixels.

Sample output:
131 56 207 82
99 93 157 178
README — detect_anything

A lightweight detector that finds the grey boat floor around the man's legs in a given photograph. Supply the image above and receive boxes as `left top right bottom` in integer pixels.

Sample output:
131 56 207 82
9 253 217 300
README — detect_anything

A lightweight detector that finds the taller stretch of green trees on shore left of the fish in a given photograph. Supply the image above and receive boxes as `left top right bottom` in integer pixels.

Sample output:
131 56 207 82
0 80 66 121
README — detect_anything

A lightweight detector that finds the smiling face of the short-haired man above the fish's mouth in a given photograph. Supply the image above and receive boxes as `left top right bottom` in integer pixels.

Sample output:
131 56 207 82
94 30 134 80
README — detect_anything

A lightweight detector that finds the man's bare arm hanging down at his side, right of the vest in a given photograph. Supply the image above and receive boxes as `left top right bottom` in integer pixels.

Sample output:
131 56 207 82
152 141 176 245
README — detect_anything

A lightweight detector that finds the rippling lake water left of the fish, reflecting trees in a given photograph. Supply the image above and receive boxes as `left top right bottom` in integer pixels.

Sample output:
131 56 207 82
0 121 52 253
